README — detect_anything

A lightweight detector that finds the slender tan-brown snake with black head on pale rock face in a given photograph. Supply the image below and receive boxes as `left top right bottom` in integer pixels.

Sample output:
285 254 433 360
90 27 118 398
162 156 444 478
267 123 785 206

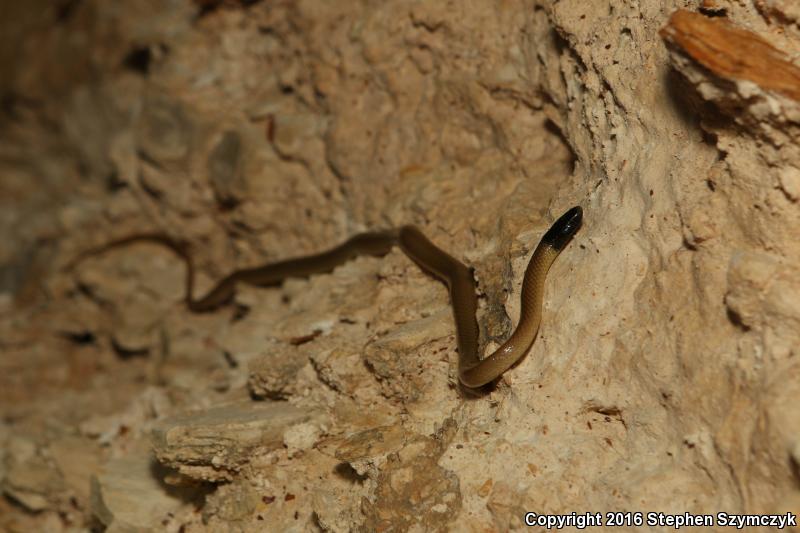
69 206 583 389
